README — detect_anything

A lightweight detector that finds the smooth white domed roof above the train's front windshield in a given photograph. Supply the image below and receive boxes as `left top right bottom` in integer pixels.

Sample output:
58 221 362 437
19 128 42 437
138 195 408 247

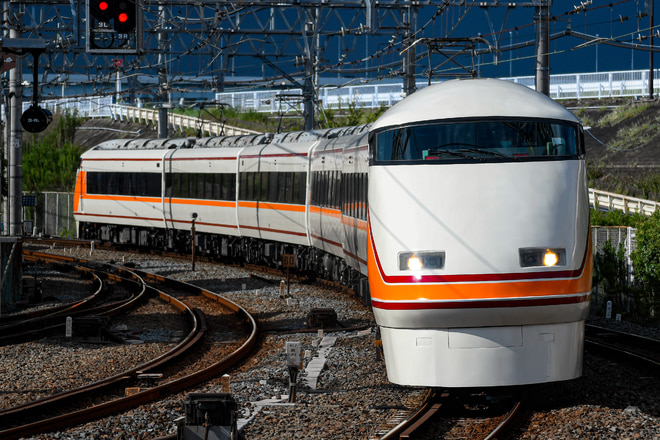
371 78 579 131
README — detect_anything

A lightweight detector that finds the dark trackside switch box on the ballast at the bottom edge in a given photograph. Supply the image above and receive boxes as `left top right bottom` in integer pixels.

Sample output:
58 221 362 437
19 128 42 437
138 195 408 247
177 393 238 440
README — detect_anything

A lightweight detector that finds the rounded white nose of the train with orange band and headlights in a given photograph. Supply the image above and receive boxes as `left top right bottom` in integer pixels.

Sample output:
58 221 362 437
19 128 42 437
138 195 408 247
368 79 592 387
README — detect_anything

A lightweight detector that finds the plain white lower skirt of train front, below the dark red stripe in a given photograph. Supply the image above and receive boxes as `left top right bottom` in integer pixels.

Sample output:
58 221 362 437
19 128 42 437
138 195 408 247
380 321 584 388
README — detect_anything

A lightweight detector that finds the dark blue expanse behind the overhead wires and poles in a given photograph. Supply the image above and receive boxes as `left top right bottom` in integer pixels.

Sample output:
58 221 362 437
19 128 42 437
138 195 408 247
32 0 660 98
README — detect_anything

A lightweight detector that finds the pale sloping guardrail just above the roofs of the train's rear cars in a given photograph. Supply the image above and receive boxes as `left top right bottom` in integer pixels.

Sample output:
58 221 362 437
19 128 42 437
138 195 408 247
110 104 259 136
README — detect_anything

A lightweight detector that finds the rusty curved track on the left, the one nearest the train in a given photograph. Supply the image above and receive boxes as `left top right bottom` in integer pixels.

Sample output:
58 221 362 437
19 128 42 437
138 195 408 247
0 253 257 439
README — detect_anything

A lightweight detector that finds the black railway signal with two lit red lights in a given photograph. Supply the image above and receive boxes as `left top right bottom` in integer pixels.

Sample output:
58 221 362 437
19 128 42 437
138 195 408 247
87 0 142 54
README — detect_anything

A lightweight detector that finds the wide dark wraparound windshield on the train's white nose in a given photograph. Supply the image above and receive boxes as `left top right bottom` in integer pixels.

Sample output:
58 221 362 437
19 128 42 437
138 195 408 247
371 119 584 162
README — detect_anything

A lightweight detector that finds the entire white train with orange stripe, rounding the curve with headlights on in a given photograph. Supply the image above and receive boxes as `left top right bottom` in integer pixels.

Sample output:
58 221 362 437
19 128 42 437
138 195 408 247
75 79 592 387
